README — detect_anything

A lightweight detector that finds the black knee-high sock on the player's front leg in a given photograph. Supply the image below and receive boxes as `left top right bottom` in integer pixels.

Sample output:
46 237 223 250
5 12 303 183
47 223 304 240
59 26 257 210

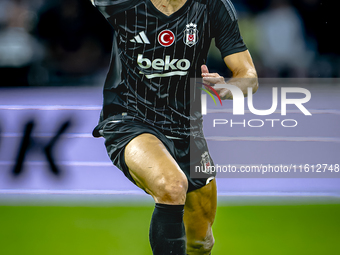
149 204 186 255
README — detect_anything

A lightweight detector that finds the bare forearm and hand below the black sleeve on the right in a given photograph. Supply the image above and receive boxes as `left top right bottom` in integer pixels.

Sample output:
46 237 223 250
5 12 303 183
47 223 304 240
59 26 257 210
202 50 258 99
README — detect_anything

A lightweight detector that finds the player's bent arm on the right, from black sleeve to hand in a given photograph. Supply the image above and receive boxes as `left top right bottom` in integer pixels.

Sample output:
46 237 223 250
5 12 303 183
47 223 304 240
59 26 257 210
202 0 258 99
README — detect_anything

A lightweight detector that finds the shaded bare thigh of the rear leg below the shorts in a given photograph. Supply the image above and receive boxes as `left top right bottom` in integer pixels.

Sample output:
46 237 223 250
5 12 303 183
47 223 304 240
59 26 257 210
184 179 217 246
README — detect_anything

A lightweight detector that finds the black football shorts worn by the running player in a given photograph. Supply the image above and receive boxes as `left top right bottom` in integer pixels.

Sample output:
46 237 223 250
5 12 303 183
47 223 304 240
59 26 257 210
97 115 215 192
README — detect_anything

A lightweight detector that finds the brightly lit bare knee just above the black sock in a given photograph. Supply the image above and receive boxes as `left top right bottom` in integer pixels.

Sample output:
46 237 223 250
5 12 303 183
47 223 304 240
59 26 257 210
154 176 188 204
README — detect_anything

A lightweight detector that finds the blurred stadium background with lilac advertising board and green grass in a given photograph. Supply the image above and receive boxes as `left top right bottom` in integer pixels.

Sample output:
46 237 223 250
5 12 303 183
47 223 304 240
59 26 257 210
0 0 340 255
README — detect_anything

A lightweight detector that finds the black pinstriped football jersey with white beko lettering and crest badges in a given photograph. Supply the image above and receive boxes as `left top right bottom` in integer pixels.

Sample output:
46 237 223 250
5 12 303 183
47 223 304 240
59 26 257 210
93 0 247 136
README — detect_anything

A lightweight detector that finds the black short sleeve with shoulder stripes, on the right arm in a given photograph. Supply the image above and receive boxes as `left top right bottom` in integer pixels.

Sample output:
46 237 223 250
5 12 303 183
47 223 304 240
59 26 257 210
210 0 247 58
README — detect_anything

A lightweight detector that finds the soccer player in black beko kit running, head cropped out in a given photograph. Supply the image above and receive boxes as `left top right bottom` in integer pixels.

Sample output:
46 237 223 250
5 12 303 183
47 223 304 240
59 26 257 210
92 0 257 255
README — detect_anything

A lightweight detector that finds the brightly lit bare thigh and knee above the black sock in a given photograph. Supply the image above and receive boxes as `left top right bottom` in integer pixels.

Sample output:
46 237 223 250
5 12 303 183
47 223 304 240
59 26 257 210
124 133 188 204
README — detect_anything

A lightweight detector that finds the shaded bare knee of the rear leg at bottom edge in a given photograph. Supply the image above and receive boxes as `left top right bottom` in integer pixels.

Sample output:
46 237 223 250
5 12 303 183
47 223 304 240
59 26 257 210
187 233 215 255
